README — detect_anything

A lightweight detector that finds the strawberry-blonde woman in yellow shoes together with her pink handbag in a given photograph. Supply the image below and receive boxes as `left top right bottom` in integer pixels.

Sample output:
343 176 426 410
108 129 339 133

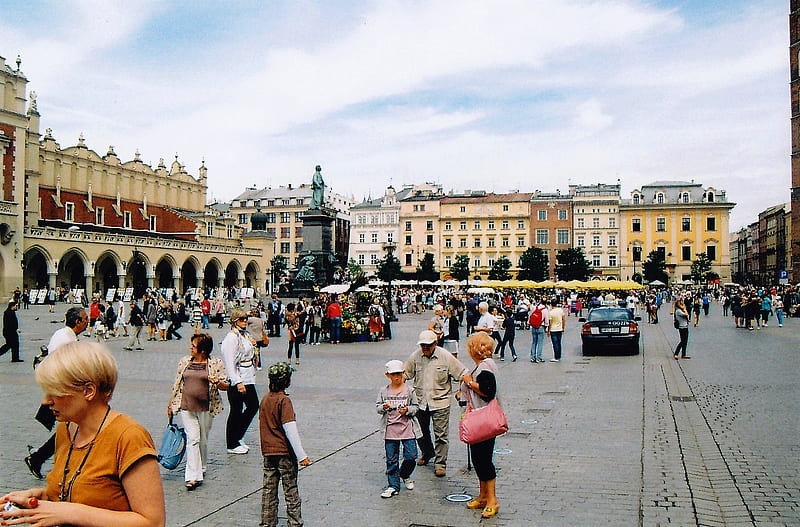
460 332 508 518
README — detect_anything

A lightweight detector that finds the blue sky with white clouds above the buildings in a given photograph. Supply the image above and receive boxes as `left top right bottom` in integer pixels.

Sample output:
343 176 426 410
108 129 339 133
0 0 791 231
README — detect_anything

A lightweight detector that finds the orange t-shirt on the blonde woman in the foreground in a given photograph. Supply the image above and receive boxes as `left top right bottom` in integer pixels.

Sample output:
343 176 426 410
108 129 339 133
47 414 157 511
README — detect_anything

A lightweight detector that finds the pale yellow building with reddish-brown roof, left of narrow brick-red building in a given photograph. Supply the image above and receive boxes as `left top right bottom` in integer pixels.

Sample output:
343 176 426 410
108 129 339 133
437 192 531 279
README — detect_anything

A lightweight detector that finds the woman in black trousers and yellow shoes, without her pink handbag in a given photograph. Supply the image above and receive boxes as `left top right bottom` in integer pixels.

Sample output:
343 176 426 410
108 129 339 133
461 331 500 518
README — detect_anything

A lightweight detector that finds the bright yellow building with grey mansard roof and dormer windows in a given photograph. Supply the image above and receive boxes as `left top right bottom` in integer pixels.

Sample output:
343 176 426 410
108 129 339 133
620 181 735 283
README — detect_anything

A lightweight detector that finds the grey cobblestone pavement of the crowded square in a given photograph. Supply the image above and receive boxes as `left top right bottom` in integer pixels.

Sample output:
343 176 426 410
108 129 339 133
0 306 800 527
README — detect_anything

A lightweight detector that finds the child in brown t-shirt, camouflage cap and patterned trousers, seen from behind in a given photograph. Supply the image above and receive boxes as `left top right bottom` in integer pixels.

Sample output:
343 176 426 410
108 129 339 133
260 360 311 527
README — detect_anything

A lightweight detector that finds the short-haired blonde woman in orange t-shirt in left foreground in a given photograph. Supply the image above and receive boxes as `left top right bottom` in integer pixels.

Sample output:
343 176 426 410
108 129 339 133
0 341 166 527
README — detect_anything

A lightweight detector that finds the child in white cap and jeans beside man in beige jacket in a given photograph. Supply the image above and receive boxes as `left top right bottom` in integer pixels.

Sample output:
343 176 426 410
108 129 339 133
375 360 422 498
